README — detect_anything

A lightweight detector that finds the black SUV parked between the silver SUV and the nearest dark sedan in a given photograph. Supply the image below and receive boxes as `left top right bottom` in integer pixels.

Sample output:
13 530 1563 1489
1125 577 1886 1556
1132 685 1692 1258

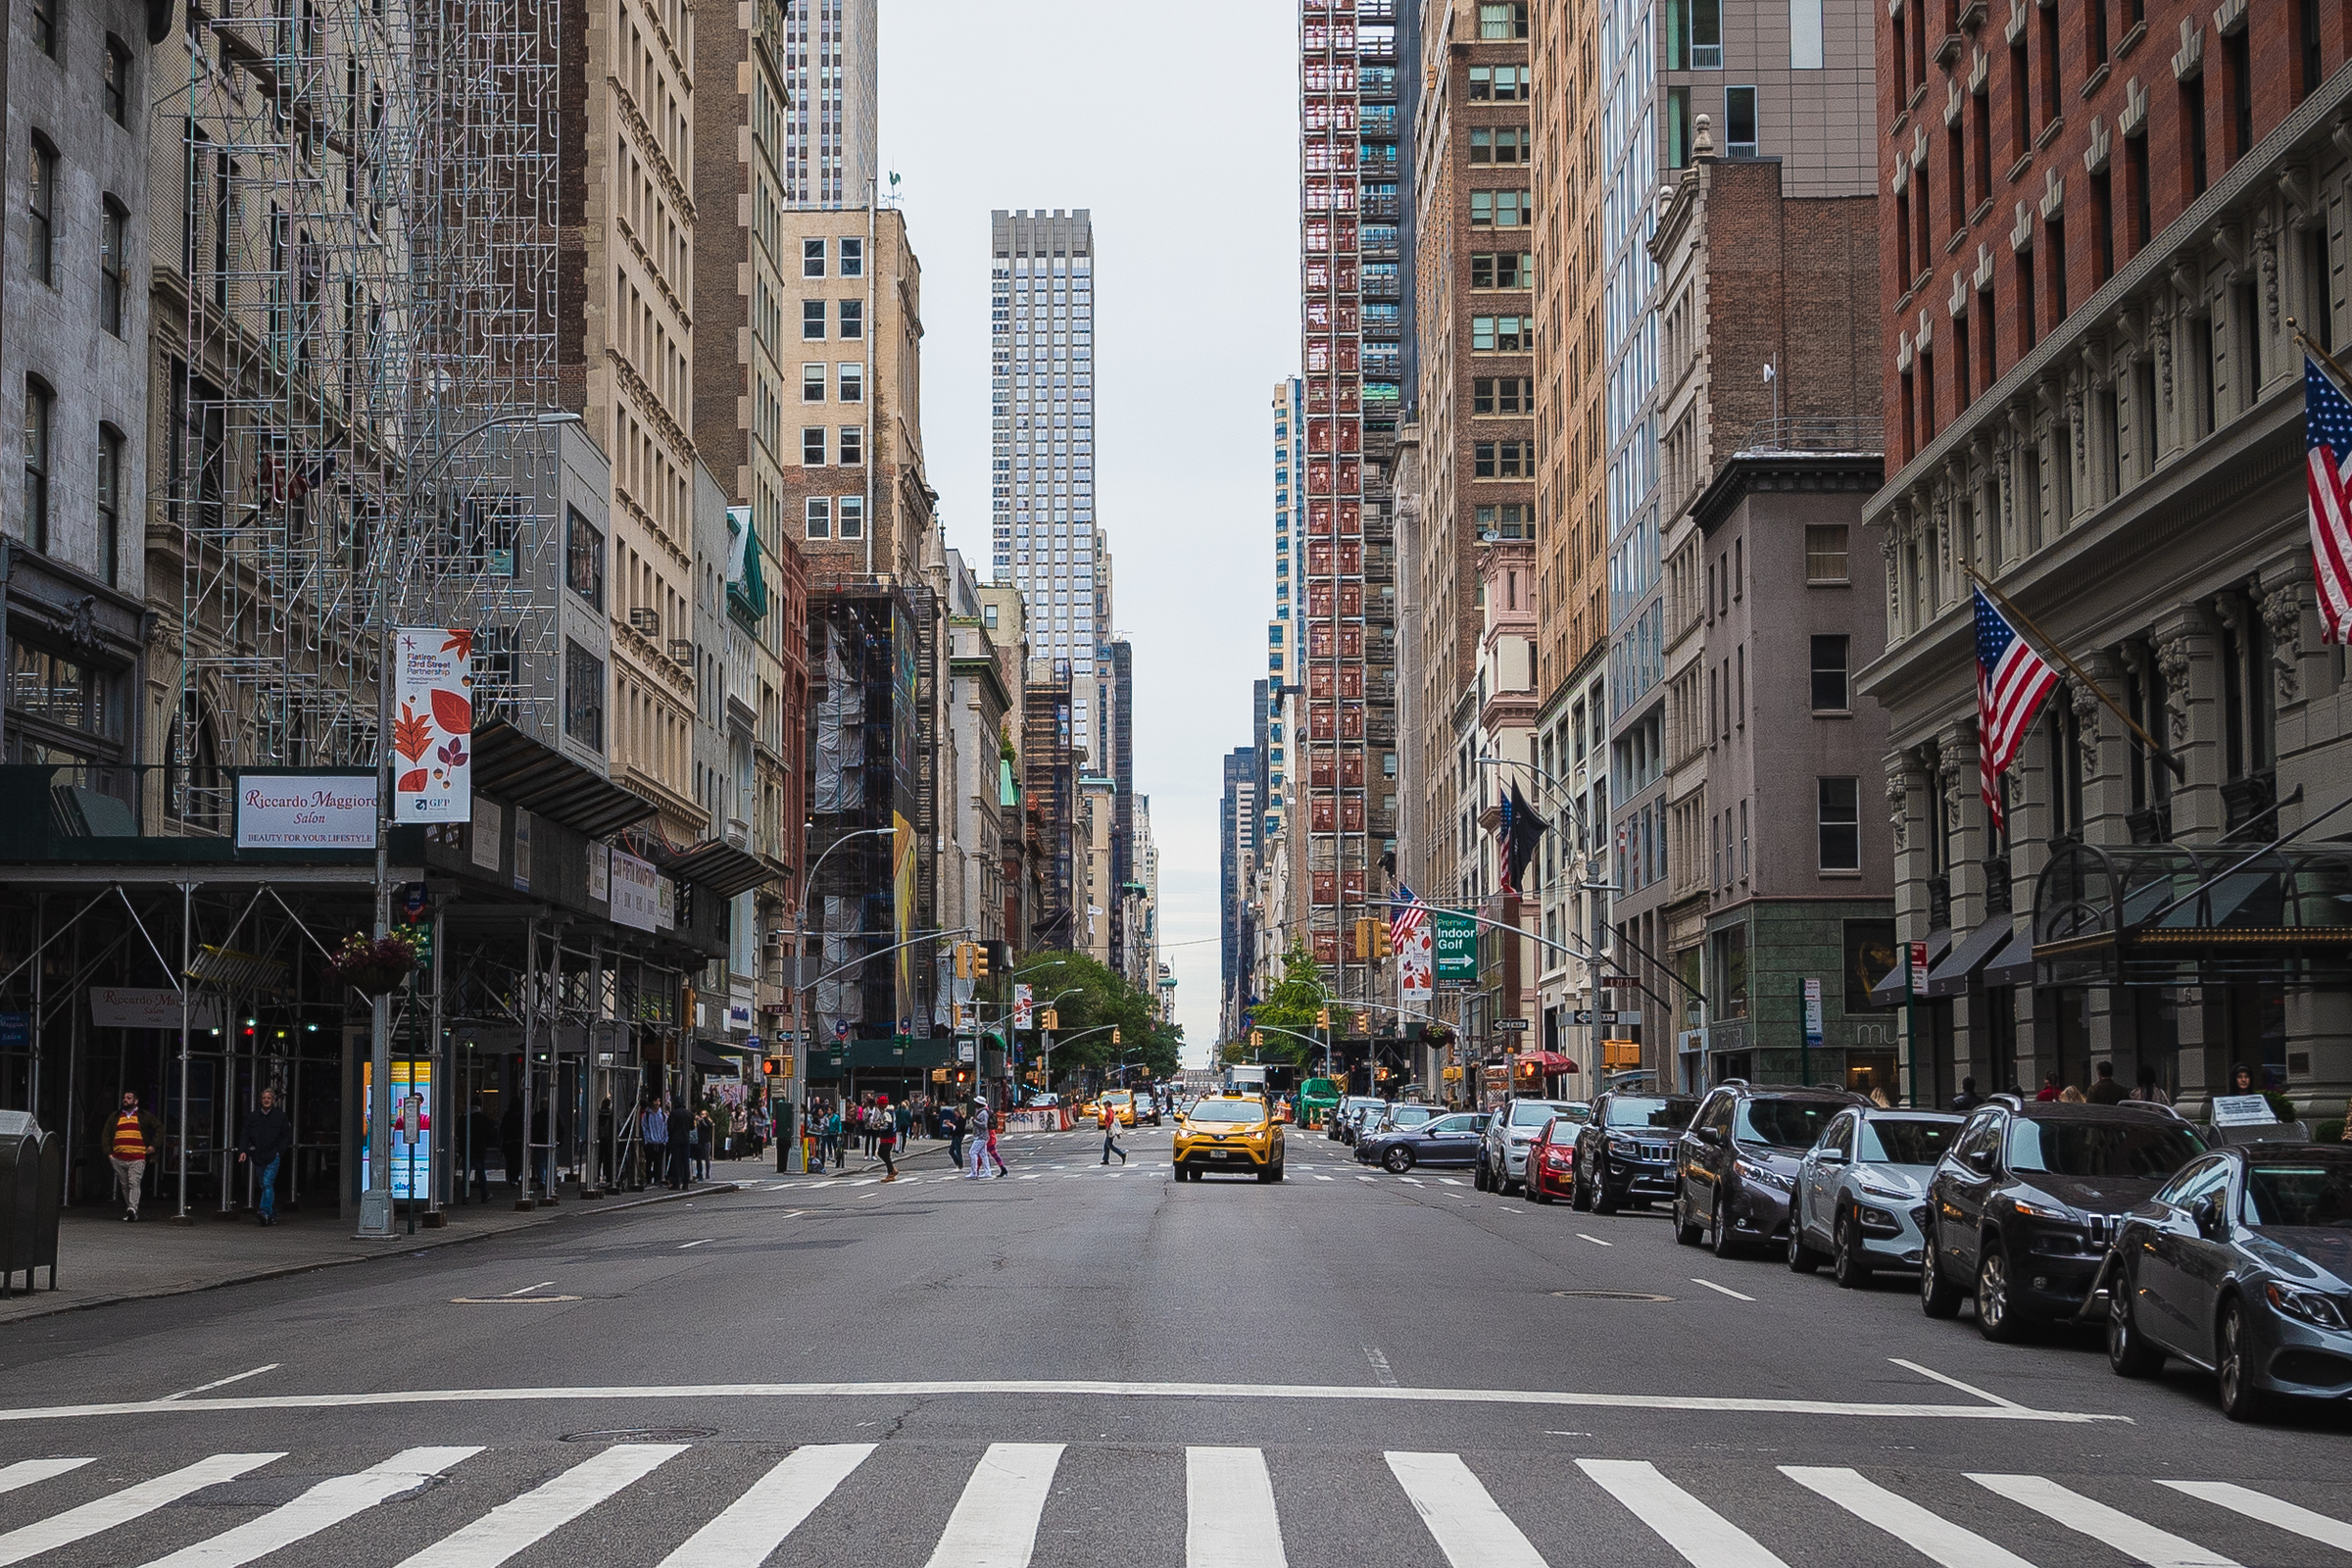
1919 1096 2204 1340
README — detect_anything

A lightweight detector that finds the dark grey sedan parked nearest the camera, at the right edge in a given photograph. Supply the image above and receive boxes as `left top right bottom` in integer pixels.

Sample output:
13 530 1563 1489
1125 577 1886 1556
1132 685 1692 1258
2103 1143 2352 1420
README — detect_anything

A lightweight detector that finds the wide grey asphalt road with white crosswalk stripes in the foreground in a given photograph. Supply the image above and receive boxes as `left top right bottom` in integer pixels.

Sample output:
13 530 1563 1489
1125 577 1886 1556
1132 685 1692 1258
0 1128 2352 1568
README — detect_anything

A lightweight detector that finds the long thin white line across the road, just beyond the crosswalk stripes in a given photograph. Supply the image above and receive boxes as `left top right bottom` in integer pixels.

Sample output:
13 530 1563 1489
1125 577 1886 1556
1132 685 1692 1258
0 1382 2129 1427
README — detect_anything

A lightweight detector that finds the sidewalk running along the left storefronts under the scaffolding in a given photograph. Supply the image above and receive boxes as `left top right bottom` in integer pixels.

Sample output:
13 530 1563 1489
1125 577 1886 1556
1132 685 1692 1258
0 1161 760 1324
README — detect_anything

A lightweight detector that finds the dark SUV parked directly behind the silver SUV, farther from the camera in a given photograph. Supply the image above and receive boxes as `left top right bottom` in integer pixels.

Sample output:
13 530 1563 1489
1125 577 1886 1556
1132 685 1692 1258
1675 1079 1865 1257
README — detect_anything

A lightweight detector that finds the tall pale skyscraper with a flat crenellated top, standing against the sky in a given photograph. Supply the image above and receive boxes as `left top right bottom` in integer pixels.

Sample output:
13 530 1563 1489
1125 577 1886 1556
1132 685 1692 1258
988 207 1112 766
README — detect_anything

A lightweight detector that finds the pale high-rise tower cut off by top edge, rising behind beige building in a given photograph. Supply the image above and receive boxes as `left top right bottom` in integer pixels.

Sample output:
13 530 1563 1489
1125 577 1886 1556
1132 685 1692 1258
781 0 882 207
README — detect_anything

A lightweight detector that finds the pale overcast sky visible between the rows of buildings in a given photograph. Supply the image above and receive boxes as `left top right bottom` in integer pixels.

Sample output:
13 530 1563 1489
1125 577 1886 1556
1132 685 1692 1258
882 0 1298 1067
